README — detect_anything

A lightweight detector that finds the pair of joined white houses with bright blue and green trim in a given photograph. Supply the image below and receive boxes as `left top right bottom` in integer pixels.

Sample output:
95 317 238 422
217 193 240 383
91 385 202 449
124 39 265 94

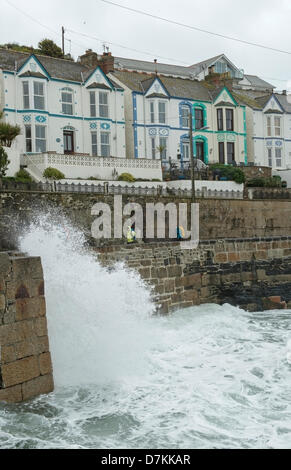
109 70 248 167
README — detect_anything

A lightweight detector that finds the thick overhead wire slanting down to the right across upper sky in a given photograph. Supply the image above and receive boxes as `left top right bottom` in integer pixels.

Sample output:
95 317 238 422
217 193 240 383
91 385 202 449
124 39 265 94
100 0 291 55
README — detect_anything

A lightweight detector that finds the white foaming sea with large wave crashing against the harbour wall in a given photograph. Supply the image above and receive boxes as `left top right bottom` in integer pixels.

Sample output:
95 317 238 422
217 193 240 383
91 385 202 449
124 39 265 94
0 215 291 449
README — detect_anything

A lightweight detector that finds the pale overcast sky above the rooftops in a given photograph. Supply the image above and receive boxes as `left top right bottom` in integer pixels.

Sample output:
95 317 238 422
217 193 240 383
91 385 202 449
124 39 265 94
0 0 291 90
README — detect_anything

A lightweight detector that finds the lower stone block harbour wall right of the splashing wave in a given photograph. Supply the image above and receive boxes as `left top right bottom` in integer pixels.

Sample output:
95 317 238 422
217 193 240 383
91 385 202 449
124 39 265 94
97 237 291 313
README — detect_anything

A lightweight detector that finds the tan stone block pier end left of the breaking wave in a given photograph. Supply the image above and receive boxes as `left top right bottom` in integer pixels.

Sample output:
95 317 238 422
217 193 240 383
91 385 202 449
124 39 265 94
0 252 54 403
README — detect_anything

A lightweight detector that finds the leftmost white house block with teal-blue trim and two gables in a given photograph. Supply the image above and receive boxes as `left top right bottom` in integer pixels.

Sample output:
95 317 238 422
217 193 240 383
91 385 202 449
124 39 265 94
0 49 125 158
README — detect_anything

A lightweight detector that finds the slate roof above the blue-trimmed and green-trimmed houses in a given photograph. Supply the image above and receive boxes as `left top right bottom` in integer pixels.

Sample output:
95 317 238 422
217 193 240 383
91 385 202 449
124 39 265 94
111 70 212 101
